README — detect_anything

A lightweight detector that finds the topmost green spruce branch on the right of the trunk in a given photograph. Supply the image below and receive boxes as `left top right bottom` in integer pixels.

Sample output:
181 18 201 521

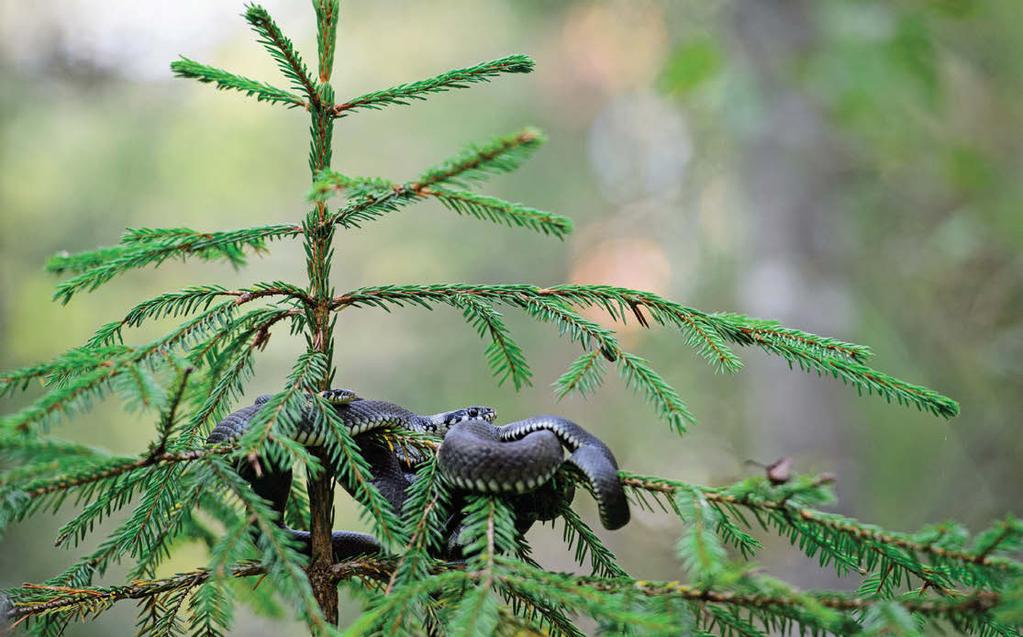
333 55 533 118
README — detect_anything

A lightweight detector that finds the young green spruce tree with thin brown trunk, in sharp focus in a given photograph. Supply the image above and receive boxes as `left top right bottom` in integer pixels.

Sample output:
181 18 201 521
0 0 1023 635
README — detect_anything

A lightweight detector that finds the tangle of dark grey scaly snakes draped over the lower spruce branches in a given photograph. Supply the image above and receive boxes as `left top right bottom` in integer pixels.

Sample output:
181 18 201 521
207 390 629 560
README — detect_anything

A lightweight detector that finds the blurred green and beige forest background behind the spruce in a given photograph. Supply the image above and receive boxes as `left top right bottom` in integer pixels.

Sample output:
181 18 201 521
0 0 1023 635
